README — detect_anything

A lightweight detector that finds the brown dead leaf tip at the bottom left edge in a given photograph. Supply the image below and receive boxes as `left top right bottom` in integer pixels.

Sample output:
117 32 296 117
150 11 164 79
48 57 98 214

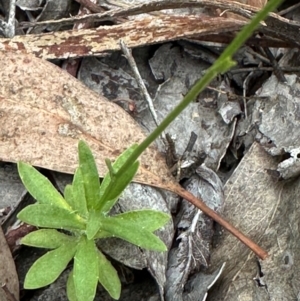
0 227 19 301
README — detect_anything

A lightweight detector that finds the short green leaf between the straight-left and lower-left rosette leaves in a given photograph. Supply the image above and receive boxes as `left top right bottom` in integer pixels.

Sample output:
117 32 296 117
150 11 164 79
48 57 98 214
21 229 76 249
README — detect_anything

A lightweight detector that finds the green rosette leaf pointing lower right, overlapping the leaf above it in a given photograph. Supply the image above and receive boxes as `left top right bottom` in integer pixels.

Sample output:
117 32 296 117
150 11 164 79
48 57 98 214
101 217 167 251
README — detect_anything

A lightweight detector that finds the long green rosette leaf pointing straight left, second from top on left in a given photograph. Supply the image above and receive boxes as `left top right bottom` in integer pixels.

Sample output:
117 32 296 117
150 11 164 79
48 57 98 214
18 204 85 230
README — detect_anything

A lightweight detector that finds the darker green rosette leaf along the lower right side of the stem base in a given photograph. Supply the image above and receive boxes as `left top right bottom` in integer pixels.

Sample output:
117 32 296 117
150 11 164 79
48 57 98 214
97 161 139 214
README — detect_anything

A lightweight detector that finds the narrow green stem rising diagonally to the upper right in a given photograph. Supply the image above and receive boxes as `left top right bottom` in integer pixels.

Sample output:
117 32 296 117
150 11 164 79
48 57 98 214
117 0 283 176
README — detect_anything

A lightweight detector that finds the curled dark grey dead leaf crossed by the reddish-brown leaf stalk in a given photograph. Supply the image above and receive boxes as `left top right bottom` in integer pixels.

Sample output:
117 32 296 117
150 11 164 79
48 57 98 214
166 164 224 301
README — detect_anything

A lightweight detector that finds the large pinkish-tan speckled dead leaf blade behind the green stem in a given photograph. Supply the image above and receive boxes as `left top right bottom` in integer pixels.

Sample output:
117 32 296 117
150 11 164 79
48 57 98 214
0 52 175 189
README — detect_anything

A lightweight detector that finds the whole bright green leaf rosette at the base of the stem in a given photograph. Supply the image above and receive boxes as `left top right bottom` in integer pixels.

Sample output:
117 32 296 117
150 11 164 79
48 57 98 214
18 141 170 301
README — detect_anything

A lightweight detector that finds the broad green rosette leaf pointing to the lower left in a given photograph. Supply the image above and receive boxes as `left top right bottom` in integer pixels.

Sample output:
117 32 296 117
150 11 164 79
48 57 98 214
24 242 76 289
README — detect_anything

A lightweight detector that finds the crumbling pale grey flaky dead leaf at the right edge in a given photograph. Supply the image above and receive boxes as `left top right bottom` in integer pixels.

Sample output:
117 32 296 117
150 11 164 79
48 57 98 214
254 74 300 179
